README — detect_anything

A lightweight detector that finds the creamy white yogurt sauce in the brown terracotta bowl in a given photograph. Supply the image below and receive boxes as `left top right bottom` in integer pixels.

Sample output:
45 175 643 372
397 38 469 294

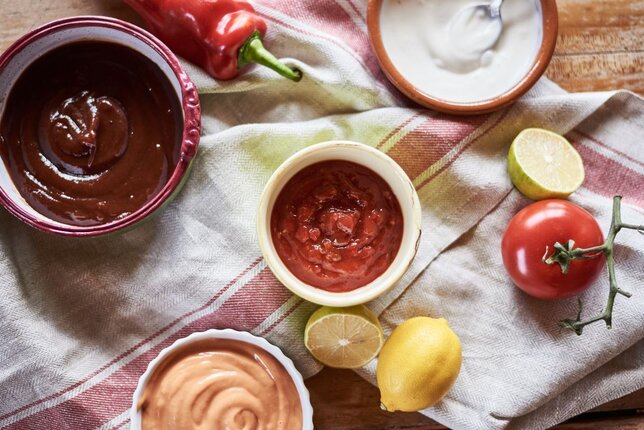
380 0 543 103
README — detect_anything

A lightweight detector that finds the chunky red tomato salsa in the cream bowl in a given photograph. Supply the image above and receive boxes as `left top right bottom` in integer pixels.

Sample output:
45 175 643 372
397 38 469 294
271 160 403 292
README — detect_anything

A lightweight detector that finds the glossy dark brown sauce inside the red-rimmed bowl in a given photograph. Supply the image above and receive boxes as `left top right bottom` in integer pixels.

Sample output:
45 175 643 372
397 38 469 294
0 41 181 226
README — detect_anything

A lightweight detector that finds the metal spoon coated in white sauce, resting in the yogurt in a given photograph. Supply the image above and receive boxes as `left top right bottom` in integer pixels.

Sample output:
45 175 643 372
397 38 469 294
448 0 503 56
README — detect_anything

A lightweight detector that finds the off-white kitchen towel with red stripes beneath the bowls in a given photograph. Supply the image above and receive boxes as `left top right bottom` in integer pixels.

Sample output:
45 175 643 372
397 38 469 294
0 0 644 430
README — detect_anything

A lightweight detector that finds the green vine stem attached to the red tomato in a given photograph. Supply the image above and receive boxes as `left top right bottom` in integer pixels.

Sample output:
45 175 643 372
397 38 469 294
543 196 644 335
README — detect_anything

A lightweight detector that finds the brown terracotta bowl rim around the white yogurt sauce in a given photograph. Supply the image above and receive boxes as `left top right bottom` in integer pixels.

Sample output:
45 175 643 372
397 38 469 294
367 0 559 115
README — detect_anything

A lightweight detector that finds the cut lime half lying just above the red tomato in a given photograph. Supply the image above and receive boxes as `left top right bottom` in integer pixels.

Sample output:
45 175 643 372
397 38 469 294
508 128 584 200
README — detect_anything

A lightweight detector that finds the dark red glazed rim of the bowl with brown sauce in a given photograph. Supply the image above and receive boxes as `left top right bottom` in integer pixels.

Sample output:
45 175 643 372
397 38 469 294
0 15 201 237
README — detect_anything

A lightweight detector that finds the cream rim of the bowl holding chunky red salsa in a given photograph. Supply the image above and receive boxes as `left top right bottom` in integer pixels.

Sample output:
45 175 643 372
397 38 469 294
256 140 422 307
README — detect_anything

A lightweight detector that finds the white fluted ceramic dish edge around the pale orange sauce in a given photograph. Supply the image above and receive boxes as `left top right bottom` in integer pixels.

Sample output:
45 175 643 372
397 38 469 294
130 329 313 430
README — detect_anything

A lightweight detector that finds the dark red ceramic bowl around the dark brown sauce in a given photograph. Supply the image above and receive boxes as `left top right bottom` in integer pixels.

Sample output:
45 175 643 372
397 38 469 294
0 16 201 236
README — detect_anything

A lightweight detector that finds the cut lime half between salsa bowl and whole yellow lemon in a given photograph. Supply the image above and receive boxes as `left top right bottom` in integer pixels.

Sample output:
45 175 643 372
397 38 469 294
304 305 385 369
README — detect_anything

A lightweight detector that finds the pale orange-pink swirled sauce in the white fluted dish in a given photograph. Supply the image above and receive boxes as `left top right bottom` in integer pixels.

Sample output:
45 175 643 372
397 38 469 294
138 339 302 430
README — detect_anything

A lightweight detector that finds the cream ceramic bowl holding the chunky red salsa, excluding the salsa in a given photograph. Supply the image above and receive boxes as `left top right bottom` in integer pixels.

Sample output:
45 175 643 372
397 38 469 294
257 140 421 306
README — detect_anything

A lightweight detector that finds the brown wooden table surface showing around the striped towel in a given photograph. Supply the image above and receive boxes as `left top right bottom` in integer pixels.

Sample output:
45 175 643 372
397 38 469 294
0 0 644 430
